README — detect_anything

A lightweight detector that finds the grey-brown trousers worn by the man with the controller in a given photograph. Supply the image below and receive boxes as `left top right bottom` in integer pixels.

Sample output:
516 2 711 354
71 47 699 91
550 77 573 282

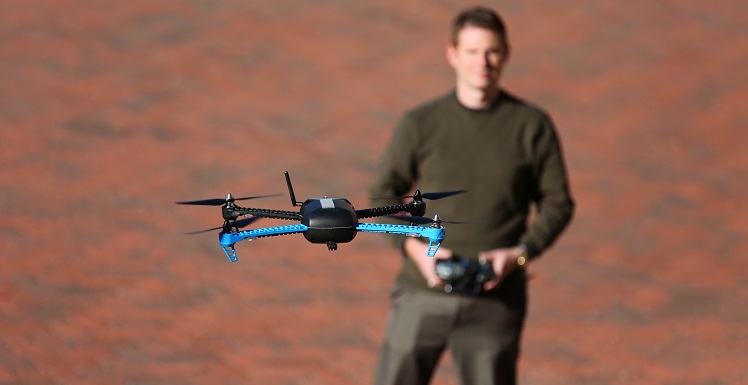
374 287 526 385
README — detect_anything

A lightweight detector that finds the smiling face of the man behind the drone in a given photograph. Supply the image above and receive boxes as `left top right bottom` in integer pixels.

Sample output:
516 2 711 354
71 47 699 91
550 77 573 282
447 25 509 91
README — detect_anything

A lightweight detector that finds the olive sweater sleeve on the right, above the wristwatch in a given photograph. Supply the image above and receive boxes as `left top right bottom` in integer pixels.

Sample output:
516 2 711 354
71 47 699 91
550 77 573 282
521 117 574 258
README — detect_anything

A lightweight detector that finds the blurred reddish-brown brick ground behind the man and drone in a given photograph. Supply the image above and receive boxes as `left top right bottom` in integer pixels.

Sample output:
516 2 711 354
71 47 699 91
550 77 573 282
0 0 748 385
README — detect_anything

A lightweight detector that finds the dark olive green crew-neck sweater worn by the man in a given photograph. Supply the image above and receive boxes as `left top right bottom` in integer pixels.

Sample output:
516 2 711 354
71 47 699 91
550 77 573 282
370 92 574 294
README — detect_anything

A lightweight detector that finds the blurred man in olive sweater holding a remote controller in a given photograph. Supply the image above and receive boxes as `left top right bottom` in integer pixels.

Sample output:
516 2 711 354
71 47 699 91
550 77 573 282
370 7 574 385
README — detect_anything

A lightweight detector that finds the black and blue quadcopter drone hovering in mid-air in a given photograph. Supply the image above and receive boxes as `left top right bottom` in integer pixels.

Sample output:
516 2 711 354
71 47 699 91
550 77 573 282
174 171 466 262
